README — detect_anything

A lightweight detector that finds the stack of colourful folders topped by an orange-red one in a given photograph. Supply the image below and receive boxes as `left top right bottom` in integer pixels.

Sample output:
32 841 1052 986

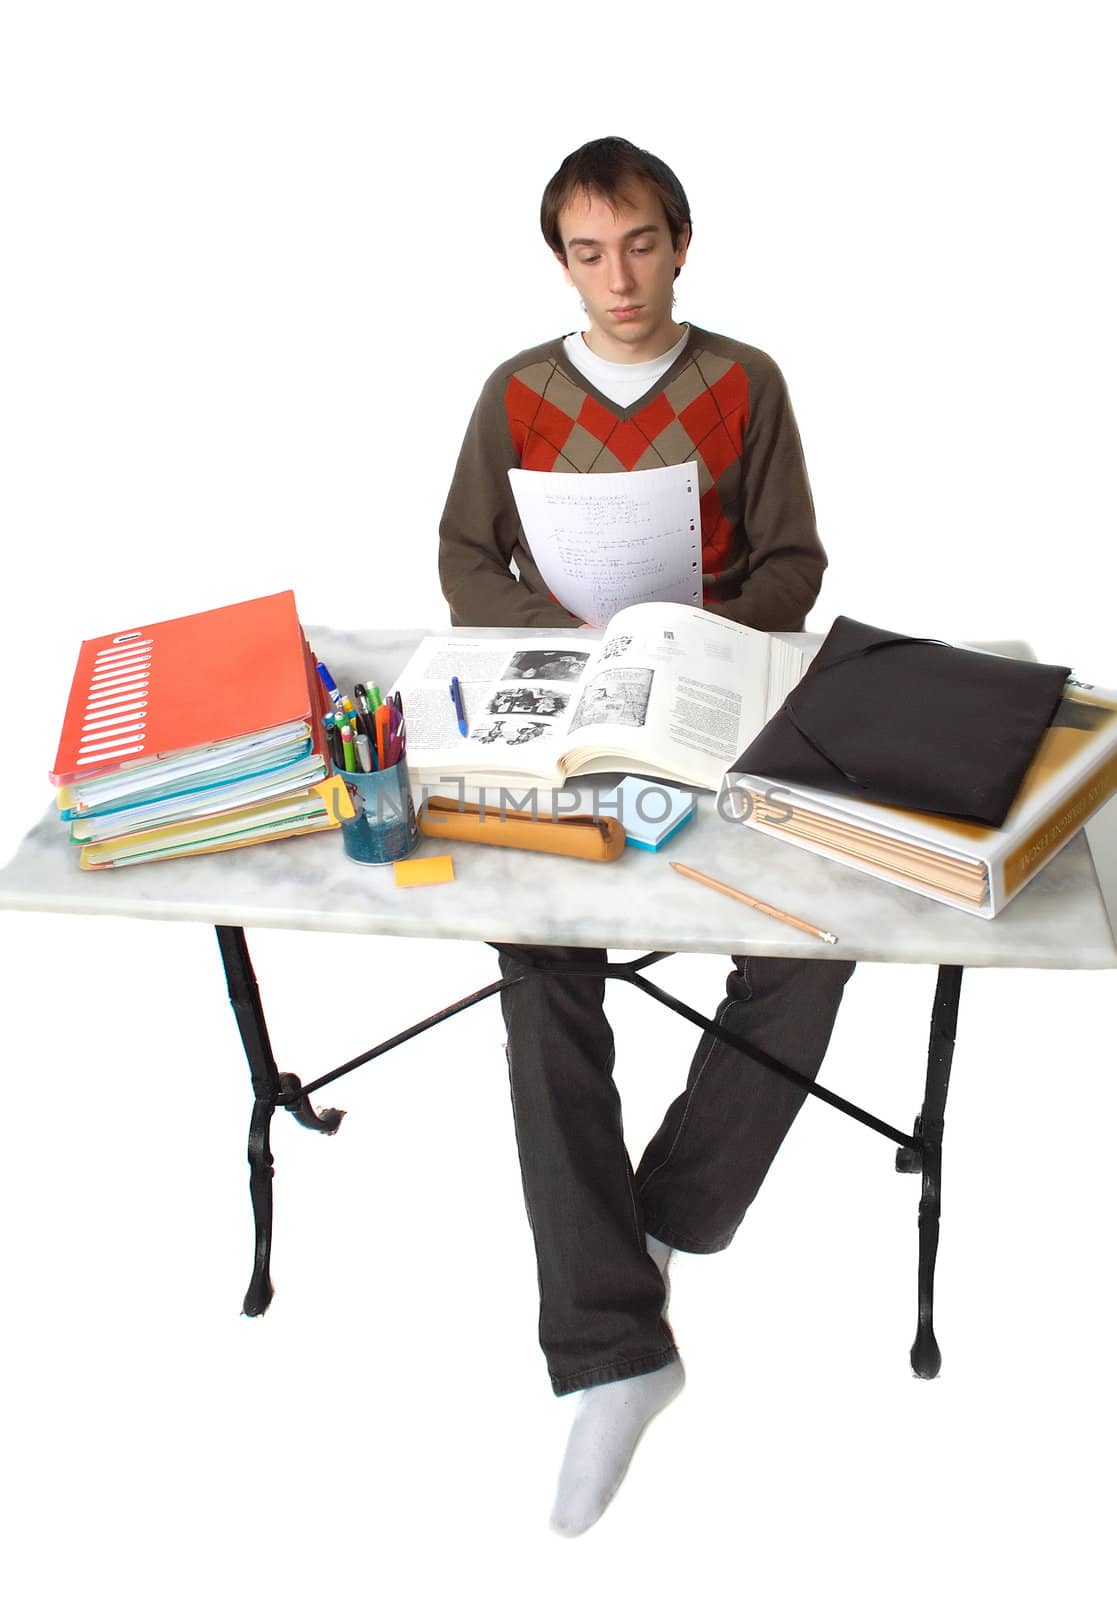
50 589 352 869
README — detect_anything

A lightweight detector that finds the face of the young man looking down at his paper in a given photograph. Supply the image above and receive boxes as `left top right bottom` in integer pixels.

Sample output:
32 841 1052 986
559 182 690 362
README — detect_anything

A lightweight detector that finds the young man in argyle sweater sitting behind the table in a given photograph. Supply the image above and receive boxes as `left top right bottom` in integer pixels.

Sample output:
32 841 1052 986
438 139 853 1534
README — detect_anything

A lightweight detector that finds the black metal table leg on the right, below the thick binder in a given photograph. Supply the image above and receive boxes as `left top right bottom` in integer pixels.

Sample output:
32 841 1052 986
896 966 962 1378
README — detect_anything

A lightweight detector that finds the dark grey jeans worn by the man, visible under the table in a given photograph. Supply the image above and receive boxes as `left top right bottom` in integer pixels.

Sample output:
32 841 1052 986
496 946 853 1395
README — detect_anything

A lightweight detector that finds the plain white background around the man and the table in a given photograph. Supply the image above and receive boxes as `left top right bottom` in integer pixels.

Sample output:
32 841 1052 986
0 0 1117 1600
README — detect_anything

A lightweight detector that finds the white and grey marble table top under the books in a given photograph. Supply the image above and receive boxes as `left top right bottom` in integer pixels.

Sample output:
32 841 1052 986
0 627 1117 968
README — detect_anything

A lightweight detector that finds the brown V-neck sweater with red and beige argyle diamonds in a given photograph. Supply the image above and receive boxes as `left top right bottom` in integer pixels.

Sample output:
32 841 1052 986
438 325 826 630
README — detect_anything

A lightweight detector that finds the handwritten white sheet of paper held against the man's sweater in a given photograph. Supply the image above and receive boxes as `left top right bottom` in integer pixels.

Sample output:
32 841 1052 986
509 461 703 627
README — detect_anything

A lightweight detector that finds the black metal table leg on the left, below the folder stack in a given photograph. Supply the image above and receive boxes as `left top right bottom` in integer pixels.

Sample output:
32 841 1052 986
218 928 344 1317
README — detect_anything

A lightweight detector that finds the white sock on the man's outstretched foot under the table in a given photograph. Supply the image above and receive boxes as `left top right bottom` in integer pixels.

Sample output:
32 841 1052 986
550 1360 685 1539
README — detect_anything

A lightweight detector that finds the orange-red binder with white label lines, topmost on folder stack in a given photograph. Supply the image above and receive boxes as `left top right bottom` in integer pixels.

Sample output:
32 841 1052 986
50 589 315 784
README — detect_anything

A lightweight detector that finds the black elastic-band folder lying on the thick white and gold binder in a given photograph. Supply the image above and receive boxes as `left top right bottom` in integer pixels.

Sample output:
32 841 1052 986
733 616 1071 827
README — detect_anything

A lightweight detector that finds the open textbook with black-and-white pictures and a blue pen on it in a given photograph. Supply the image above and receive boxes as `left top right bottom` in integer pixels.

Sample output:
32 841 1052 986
395 602 807 789
